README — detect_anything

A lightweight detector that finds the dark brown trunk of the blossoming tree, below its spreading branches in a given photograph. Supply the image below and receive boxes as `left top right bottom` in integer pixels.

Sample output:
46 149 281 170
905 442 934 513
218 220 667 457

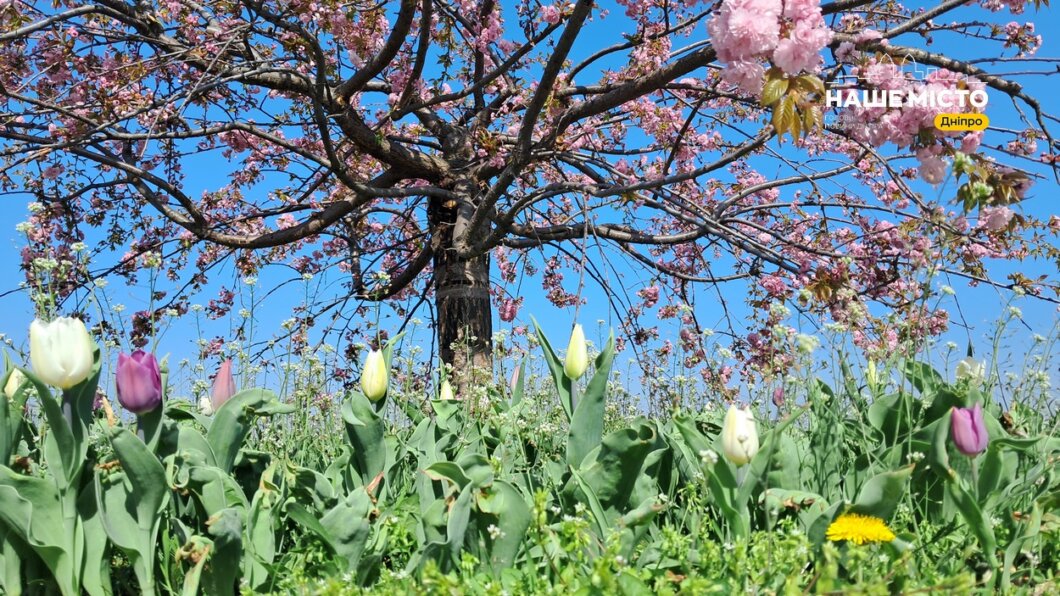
434 189 493 399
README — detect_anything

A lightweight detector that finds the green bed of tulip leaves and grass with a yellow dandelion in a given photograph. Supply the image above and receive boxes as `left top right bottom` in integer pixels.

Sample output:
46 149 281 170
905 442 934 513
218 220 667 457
0 313 1060 594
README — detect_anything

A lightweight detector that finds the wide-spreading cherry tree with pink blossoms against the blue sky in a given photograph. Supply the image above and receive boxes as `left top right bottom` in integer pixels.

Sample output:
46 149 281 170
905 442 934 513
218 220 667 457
0 0 1060 382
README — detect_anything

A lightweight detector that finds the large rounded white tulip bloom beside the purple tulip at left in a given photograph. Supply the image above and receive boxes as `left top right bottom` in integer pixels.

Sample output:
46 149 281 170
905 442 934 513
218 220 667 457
30 317 95 389
